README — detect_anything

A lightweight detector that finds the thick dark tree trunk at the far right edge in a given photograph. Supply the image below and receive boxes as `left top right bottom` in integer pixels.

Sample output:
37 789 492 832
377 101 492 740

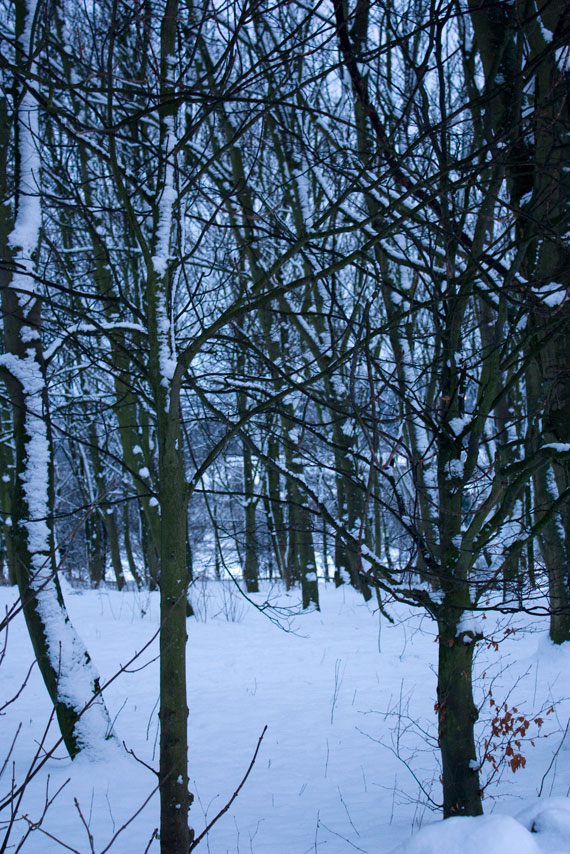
468 0 570 643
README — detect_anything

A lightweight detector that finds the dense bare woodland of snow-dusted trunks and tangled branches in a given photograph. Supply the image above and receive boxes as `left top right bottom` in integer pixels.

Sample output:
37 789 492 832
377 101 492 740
0 0 570 854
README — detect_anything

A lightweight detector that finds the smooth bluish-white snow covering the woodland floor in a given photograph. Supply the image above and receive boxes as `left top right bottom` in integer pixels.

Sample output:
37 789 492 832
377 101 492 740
0 582 570 854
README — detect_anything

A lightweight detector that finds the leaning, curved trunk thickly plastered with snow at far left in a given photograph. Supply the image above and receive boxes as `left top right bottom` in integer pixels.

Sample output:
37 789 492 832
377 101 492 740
0 0 112 757
